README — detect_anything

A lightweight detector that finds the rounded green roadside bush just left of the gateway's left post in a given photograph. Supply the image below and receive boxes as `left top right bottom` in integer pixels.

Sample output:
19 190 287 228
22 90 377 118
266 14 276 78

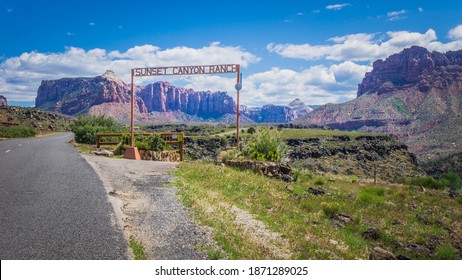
71 115 123 144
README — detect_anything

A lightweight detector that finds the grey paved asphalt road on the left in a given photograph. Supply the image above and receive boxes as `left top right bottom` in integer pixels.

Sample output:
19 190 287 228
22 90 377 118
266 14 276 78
0 133 128 260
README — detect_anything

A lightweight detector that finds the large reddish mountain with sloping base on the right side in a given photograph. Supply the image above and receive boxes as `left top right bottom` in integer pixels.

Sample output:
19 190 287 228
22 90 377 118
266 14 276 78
294 47 462 160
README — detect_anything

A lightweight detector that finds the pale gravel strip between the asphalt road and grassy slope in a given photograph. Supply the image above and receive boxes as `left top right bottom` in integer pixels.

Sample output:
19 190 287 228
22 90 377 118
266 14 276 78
82 155 213 260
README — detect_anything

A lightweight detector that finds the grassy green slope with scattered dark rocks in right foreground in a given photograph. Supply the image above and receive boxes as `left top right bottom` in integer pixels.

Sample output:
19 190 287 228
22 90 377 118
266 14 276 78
174 162 462 260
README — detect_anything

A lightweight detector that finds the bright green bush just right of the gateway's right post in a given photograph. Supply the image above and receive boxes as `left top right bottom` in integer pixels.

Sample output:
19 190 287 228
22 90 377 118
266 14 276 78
248 128 286 162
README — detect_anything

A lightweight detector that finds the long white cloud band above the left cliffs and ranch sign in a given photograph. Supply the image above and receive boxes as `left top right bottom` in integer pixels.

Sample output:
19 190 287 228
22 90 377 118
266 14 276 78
0 42 260 101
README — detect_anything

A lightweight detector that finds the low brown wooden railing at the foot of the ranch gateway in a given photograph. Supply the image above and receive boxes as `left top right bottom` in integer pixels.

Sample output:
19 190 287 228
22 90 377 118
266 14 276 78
96 132 184 161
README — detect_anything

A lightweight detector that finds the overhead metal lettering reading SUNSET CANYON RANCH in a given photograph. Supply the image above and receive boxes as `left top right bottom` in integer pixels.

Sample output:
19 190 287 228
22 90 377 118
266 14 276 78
133 64 239 76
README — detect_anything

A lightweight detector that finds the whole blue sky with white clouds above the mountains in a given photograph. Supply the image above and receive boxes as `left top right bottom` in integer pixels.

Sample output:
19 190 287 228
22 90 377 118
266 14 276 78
0 0 462 106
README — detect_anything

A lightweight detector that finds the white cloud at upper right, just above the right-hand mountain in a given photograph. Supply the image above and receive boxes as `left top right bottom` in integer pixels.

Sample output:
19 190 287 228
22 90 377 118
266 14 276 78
266 26 462 62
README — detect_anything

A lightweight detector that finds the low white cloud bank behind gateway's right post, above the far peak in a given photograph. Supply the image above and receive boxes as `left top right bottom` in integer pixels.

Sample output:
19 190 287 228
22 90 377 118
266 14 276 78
181 61 372 106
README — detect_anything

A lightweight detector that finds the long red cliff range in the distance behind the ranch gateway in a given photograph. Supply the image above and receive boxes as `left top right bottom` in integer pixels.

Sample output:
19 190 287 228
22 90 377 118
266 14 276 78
35 70 312 123
